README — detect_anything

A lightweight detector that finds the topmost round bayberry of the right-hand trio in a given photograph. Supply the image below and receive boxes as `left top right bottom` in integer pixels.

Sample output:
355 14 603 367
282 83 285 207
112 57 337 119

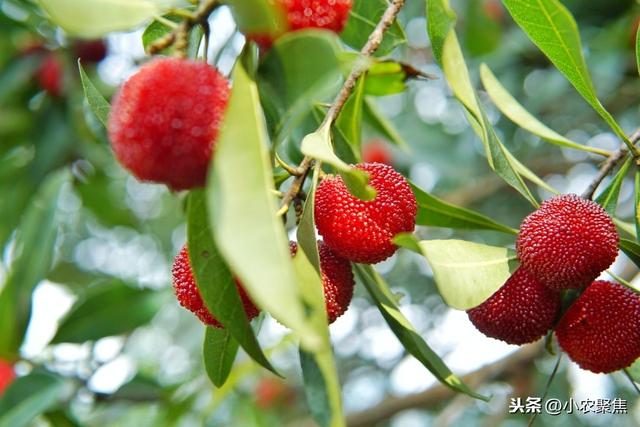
516 194 618 289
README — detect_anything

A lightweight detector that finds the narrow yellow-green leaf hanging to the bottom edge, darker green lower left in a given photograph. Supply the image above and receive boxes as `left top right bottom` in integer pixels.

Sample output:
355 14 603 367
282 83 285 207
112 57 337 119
293 248 345 427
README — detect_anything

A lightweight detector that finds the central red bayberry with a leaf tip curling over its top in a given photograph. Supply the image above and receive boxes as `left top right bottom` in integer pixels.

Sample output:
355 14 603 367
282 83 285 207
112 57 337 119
315 163 417 264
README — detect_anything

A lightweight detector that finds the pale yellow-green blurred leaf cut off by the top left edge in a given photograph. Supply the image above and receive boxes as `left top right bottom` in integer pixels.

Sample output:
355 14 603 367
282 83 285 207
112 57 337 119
38 0 178 38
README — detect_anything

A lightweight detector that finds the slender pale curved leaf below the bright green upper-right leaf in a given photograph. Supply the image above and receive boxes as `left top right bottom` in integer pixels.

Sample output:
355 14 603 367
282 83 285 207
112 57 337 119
480 64 609 156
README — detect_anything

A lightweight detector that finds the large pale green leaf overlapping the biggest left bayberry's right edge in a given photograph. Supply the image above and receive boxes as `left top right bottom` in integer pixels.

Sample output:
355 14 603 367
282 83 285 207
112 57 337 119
207 65 322 349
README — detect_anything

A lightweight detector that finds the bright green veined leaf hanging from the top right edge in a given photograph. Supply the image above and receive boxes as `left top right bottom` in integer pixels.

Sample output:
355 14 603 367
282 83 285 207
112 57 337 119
502 0 628 146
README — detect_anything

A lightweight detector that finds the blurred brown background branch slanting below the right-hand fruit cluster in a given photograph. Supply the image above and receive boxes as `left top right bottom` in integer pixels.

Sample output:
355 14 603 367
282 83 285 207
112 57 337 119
347 342 543 427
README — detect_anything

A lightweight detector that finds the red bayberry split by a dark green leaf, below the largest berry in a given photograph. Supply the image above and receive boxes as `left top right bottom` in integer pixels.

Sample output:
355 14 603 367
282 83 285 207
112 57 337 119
172 245 260 328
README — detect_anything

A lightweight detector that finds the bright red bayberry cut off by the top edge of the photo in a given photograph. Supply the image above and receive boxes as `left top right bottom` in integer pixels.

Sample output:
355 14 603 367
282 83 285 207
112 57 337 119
248 0 353 49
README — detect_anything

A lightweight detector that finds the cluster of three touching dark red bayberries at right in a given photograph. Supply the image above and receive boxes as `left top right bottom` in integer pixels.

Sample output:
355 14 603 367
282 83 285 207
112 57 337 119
468 194 640 373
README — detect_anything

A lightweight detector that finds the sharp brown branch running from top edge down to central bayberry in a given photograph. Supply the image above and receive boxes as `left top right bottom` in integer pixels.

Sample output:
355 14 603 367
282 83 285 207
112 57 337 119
278 0 405 215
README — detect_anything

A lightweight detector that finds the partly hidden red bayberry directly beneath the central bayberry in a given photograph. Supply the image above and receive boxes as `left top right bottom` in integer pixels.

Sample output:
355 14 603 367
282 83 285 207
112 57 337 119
289 241 355 323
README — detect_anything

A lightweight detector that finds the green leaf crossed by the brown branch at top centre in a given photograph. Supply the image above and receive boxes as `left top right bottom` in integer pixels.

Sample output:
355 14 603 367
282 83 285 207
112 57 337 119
340 0 407 56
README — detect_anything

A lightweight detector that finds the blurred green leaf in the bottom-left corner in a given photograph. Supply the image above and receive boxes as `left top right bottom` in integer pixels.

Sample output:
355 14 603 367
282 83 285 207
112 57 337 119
0 372 64 427
